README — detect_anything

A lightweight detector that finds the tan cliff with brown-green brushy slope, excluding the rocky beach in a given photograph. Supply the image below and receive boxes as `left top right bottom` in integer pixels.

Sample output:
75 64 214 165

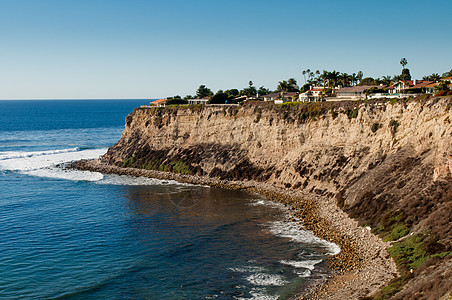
102 97 452 299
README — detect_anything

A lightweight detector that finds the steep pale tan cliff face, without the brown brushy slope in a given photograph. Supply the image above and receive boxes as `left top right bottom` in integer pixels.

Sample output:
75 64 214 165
105 99 452 195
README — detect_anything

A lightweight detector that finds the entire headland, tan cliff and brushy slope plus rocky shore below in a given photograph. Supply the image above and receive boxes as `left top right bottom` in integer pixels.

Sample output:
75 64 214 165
72 97 452 299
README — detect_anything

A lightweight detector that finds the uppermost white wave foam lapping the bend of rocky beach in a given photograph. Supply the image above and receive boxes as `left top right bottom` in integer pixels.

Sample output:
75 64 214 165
270 221 341 255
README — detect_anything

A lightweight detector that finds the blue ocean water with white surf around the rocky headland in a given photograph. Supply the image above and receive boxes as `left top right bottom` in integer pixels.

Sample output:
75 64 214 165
0 100 337 299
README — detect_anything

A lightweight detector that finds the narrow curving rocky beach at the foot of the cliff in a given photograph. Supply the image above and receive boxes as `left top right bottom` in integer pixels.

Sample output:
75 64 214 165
69 159 397 299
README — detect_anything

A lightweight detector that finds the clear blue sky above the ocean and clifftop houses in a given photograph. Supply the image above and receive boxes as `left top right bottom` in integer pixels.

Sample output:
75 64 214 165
0 0 452 99
